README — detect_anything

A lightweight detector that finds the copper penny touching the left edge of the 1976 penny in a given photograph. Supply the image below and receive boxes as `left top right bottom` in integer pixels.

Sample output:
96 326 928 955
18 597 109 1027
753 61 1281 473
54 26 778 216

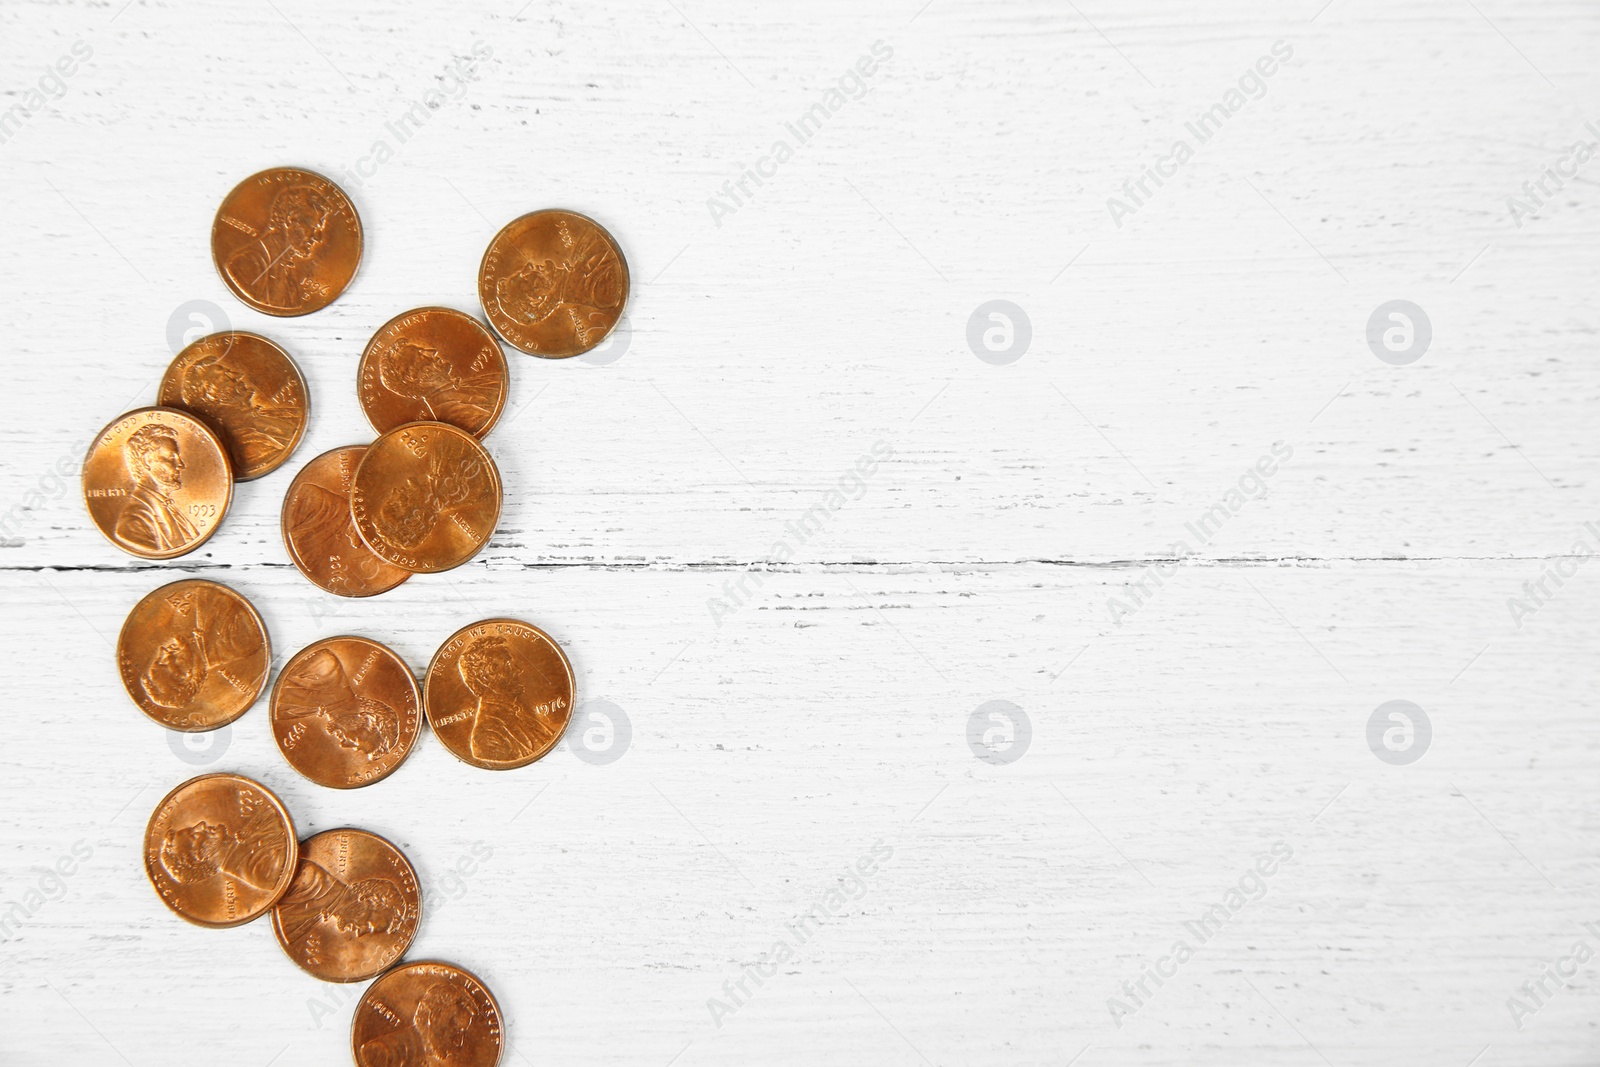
272 637 422 789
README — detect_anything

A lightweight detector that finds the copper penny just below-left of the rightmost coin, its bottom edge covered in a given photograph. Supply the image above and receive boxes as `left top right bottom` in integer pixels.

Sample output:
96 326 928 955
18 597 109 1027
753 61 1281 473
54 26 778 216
355 307 510 437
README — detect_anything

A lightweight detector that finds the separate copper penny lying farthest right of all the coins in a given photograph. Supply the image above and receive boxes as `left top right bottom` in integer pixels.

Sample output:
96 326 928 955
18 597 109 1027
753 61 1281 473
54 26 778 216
478 211 627 358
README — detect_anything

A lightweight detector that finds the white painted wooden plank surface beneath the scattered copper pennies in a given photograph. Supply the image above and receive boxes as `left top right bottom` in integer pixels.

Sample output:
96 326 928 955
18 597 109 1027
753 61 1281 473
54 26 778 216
0 0 1600 1067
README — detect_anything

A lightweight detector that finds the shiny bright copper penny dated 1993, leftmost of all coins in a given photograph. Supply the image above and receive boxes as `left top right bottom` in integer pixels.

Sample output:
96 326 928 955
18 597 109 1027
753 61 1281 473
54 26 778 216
83 408 234 560
